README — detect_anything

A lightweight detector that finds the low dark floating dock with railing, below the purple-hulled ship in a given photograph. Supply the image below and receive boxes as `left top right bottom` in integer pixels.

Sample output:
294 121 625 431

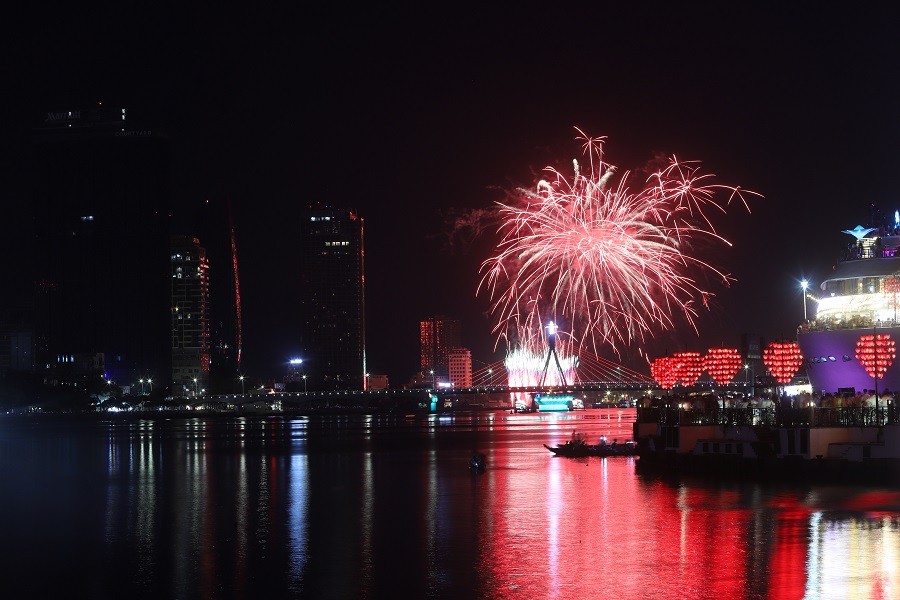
634 402 900 485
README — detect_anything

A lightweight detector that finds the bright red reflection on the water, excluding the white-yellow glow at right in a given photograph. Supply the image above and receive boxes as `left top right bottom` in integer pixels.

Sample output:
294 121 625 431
480 428 750 598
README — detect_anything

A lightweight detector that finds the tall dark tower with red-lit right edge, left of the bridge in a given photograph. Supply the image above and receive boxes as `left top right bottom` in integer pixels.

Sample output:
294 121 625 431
299 208 366 390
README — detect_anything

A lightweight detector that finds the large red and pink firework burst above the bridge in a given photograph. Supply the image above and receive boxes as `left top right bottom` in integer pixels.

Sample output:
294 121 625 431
477 128 759 378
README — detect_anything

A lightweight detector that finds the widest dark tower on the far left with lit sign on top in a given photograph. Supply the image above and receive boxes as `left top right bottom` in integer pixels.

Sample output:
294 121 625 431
23 106 170 385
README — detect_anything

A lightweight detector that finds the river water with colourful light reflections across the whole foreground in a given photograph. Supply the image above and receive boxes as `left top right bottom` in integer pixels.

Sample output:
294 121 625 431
0 409 900 600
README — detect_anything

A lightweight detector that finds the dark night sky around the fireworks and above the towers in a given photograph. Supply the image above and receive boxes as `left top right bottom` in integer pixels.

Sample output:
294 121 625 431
0 2 900 384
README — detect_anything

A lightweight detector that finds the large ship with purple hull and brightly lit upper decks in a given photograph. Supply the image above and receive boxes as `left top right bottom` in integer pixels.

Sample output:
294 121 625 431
797 220 900 394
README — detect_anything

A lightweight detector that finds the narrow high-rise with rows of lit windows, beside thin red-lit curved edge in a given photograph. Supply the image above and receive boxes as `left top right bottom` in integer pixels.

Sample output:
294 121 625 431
171 236 210 396
